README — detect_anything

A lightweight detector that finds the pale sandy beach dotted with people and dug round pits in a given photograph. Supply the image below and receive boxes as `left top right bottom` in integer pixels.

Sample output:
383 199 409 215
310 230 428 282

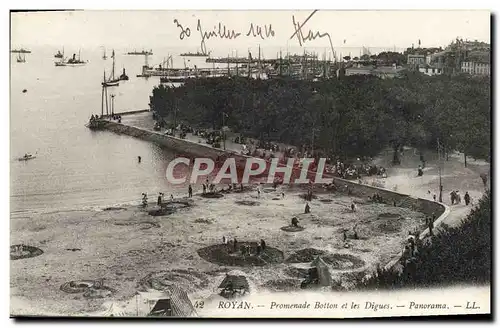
10 184 425 315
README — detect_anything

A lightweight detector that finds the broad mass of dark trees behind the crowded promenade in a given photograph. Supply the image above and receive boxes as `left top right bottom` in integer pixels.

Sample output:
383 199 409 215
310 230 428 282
150 72 491 163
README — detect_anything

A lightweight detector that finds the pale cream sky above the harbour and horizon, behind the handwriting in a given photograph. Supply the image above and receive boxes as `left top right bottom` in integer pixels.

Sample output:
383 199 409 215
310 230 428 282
11 10 490 51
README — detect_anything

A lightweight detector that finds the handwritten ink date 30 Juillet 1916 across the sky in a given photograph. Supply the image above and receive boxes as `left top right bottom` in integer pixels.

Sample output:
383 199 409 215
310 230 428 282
174 19 276 54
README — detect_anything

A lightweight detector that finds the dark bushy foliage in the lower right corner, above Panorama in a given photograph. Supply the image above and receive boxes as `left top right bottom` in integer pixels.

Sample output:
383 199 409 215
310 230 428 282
358 192 492 289
